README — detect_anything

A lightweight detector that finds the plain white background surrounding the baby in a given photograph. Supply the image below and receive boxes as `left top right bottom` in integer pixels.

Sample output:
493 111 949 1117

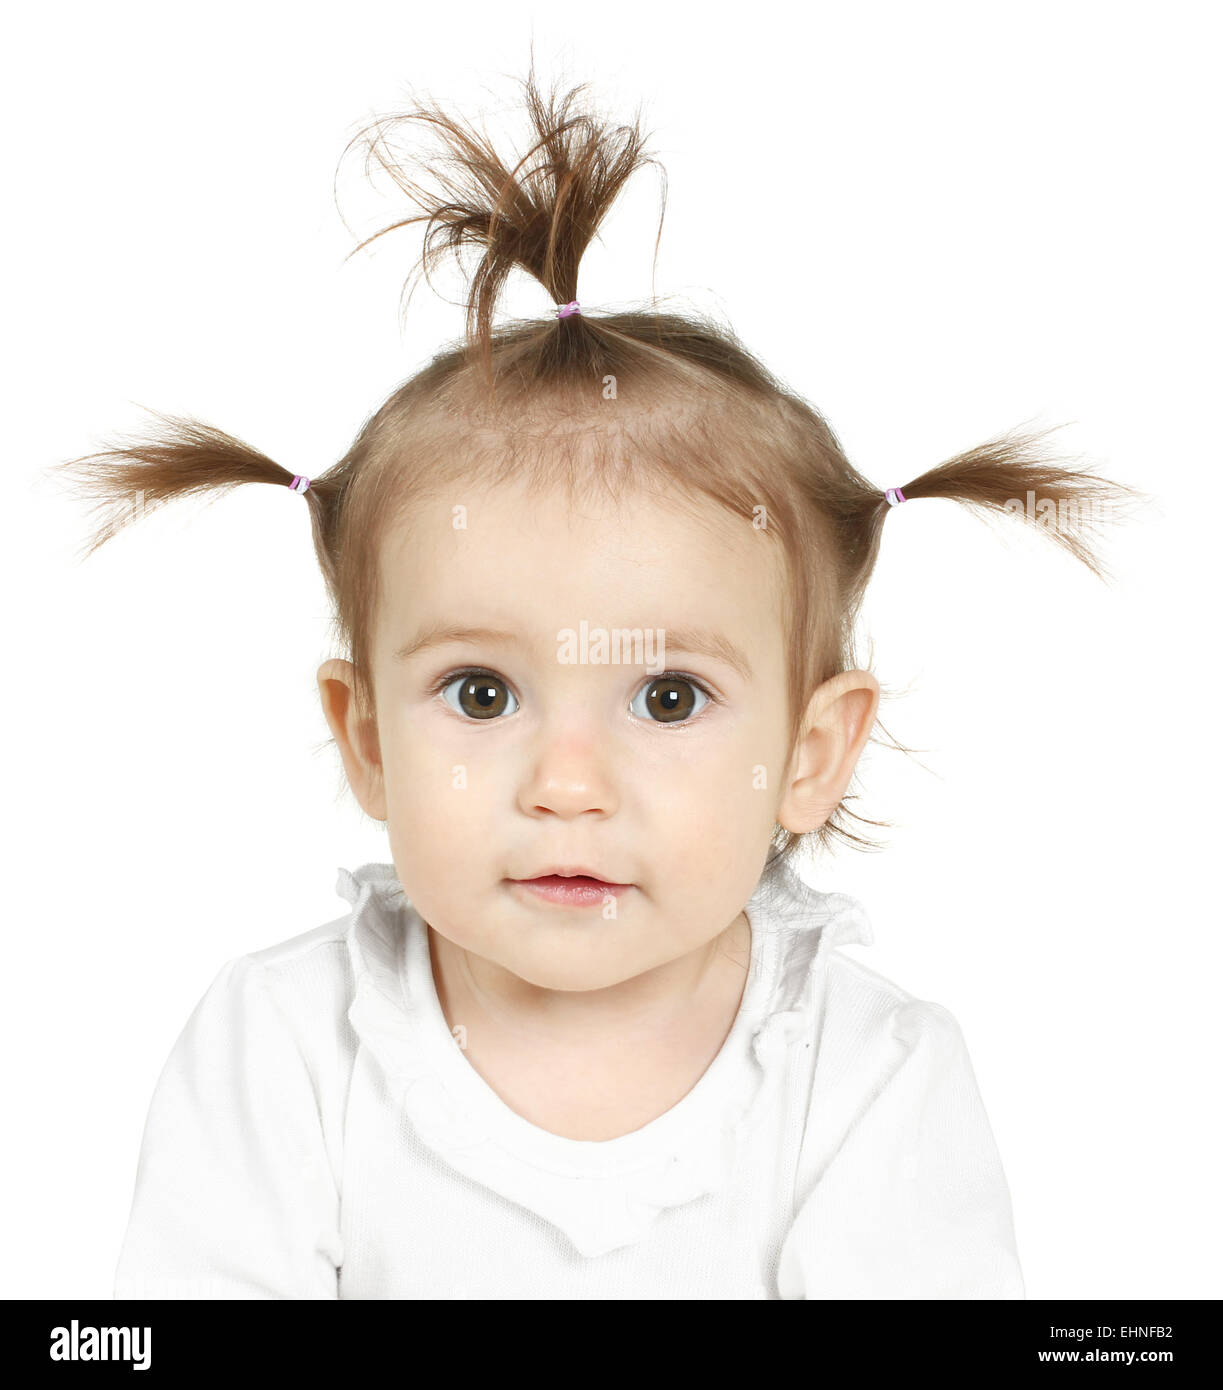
0 0 1223 1298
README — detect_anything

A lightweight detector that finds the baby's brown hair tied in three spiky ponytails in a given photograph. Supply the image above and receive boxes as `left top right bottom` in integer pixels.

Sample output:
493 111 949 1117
45 70 1138 863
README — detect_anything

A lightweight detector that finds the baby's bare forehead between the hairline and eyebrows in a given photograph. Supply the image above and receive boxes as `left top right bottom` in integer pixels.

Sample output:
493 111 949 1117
384 478 782 667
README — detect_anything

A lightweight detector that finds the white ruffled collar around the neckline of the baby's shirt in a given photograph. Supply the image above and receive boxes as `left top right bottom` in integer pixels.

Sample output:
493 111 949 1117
336 863 874 1257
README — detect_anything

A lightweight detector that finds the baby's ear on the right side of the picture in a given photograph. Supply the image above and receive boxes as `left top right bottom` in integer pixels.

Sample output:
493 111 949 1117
777 671 880 835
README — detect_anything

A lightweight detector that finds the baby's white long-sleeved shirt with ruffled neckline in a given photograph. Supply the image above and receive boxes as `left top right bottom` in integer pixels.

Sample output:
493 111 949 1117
115 863 1024 1300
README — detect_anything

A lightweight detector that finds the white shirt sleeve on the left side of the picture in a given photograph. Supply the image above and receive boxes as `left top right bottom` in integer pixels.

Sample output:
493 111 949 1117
114 956 342 1298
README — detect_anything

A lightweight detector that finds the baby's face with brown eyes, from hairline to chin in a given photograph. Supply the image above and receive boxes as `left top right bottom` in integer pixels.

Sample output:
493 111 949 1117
332 484 788 990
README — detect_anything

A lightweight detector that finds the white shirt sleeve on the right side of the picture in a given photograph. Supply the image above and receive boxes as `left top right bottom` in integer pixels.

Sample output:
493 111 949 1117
778 999 1024 1298
